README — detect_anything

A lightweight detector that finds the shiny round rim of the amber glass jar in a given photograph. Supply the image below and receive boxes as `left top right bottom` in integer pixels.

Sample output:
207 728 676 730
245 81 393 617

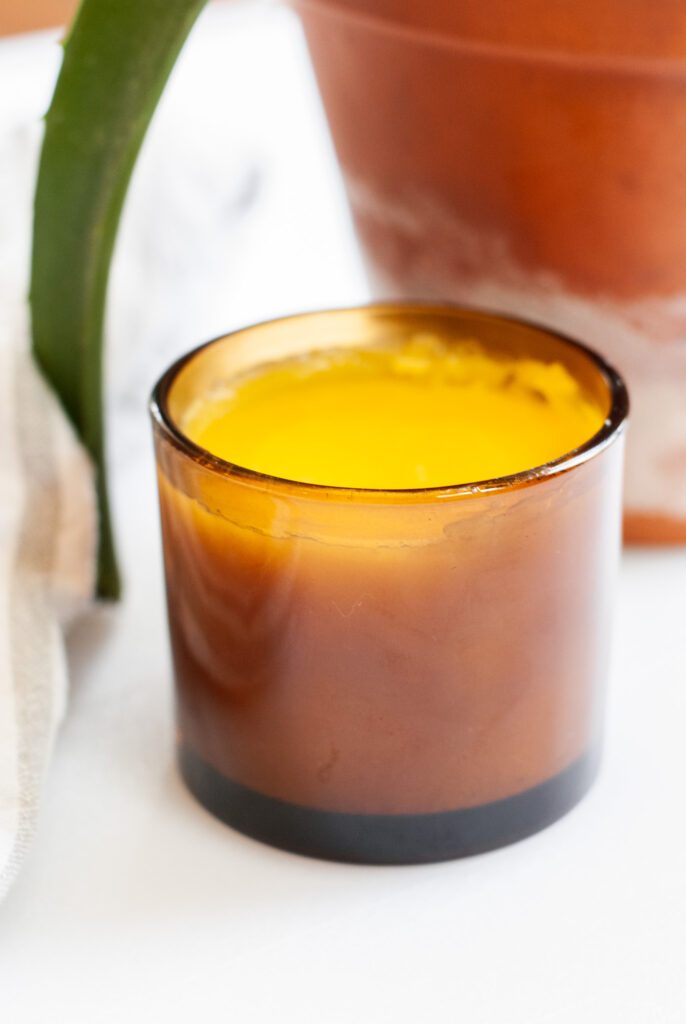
149 302 630 504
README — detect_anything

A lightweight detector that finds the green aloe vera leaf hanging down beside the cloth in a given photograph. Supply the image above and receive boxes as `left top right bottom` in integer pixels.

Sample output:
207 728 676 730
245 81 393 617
31 0 205 598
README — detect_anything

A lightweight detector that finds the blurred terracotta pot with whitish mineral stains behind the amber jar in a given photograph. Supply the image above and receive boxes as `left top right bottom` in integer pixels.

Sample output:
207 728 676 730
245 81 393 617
297 0 686 542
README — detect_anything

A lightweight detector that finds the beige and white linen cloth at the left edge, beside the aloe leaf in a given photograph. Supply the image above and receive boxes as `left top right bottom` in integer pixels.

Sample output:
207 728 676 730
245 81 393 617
0 125 97 900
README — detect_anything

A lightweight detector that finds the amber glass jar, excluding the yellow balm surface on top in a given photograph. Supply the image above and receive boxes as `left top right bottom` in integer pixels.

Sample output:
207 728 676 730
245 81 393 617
152 305 628 863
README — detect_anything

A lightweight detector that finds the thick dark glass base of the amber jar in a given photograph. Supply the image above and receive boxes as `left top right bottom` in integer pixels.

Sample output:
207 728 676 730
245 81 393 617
179 746 598 864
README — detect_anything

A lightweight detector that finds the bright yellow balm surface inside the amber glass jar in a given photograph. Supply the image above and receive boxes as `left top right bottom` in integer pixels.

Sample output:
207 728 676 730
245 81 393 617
180 336 604 489
